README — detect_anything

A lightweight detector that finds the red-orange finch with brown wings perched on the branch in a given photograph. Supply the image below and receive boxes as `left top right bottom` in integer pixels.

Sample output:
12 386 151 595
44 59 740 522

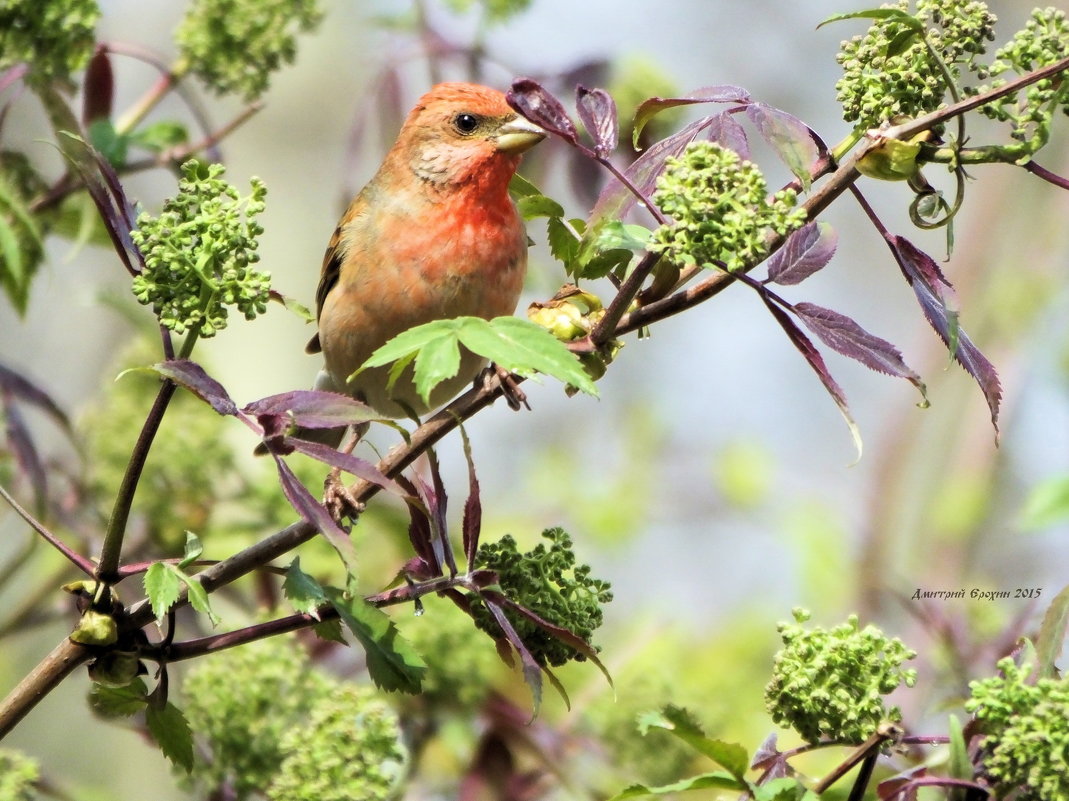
306 82 546 440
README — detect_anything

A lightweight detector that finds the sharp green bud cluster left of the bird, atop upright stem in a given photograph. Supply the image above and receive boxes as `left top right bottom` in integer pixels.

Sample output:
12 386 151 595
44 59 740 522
130 160 270 337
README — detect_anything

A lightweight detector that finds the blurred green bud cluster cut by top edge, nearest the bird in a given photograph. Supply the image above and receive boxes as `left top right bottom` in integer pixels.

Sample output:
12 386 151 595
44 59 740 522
176 0 323 102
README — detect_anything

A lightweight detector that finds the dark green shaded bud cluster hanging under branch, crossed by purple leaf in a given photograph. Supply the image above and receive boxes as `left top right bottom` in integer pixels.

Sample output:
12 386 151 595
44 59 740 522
471 528 613 666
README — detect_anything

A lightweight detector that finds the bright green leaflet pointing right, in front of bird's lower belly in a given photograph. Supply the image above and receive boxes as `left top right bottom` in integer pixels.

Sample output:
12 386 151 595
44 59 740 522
460 317 598 397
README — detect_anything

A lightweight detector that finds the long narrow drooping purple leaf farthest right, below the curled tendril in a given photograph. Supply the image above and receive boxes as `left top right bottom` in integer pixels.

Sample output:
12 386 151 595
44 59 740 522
887 235 1002 434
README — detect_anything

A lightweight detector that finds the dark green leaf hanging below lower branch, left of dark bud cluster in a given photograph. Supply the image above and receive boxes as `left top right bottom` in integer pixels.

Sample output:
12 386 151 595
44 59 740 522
324 587 427 695
